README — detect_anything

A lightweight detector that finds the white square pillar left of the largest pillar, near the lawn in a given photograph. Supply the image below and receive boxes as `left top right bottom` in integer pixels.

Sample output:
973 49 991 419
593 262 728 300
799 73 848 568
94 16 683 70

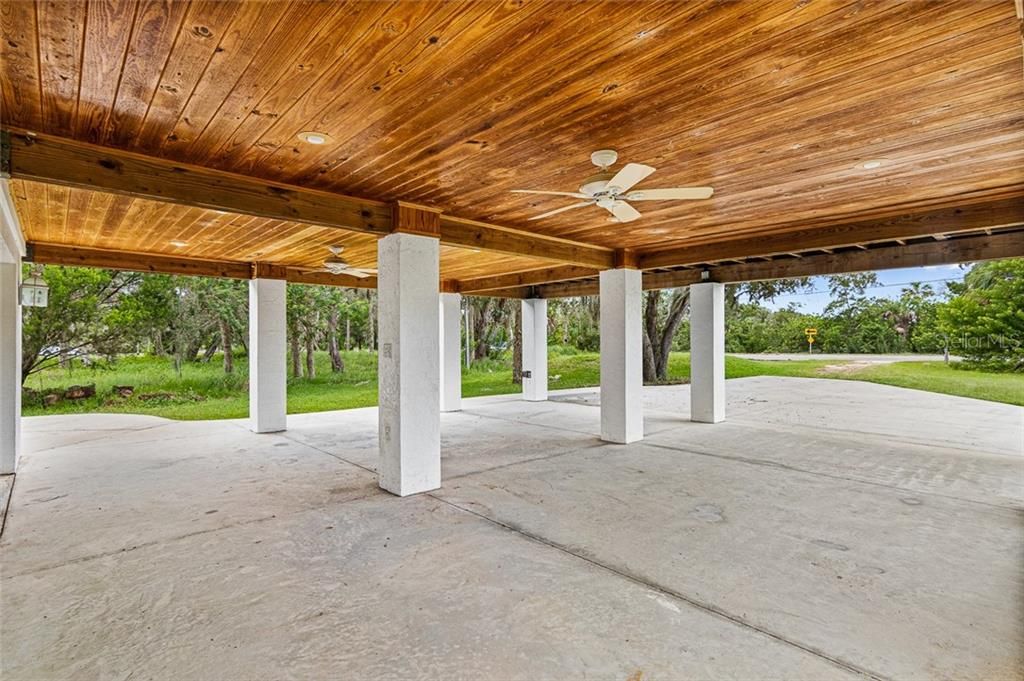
249 279 288 433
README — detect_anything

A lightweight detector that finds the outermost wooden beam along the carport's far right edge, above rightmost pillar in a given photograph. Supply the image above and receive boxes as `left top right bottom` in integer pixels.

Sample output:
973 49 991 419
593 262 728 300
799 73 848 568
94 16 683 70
528 230 1024 298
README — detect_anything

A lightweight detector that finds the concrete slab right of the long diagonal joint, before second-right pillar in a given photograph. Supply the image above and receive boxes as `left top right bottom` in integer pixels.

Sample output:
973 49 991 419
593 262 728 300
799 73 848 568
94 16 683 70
439 444 1024 678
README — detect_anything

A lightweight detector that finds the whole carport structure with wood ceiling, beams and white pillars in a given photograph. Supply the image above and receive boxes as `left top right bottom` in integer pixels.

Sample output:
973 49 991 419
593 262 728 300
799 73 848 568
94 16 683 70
0 0 1024 496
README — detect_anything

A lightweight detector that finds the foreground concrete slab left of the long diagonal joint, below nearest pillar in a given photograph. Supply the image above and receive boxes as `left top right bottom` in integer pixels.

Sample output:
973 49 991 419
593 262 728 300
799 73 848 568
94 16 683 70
4 493 853 679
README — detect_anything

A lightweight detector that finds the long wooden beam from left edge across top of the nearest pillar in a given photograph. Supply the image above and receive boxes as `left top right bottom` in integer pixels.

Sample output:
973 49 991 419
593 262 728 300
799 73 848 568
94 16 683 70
0 130 613 267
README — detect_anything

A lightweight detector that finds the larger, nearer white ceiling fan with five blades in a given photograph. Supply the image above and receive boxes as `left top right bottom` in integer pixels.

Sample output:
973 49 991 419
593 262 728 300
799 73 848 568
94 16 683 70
512 150 715 222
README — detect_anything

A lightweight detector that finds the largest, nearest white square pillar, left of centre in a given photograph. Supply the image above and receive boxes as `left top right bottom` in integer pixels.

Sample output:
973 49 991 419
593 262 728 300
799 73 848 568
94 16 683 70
377 232 441 497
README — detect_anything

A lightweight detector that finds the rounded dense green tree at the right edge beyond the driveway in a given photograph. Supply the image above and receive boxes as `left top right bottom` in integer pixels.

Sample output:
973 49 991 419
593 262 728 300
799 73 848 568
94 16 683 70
938 258 1024 372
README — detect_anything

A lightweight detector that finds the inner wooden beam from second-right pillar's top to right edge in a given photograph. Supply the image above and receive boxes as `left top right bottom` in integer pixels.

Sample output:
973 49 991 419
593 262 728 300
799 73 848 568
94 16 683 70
640 197 1024 269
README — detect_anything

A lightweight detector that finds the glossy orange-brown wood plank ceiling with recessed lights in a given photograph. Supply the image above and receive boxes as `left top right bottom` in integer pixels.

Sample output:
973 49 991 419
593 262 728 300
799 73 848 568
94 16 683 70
0 0 1024 279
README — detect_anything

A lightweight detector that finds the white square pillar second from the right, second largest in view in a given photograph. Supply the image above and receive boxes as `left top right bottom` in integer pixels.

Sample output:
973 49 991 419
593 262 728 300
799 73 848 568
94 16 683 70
600 268 643 444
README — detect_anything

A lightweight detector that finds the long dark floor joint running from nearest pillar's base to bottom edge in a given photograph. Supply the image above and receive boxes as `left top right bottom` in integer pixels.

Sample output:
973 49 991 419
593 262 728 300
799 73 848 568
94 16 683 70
424 493 893 681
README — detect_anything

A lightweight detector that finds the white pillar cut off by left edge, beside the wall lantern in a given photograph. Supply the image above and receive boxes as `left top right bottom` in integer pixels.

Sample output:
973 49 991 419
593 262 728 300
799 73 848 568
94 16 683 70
0 241 22 474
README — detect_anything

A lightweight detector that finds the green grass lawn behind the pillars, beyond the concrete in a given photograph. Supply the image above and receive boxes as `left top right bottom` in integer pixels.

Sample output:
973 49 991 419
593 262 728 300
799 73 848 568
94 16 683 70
23 347 1024 420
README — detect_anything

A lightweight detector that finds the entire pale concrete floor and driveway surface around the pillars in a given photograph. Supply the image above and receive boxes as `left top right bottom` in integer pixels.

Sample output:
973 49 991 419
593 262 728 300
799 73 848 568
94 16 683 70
0 378 1024 681
